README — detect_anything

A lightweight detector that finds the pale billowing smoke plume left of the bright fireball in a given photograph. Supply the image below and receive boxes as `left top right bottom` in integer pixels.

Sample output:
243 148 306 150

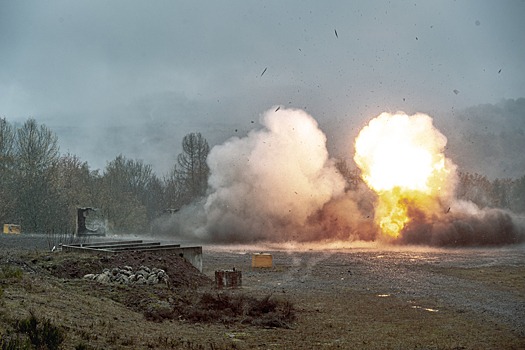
158 108 370 242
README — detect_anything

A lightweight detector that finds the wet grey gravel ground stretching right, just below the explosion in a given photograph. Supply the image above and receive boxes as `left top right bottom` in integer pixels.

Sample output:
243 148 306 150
204 245 525 337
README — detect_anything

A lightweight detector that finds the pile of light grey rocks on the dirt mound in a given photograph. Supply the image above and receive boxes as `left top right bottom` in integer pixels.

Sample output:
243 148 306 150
84 266 169 285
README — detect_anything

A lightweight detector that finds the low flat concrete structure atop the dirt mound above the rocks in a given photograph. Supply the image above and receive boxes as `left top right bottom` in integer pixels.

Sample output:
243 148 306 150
62 240 202 272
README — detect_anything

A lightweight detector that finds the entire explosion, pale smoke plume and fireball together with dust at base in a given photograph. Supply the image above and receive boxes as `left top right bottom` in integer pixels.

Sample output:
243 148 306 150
158 108 525 246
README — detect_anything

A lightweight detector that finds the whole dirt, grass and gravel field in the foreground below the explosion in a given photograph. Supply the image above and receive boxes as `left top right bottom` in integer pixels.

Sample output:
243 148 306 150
0 236 525 349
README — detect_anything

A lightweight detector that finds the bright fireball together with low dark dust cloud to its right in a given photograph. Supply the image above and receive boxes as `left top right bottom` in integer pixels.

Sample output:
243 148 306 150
354 112 525 246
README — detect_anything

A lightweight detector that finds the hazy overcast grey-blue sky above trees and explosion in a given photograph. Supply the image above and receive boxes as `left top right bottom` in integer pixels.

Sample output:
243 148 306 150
0 0 525 174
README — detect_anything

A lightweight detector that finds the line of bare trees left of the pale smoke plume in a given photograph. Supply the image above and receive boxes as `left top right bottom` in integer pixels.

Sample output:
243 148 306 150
0 118 210 234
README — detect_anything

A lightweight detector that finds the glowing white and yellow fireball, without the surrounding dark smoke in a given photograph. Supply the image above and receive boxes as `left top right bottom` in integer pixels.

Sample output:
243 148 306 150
354 112 455 239
